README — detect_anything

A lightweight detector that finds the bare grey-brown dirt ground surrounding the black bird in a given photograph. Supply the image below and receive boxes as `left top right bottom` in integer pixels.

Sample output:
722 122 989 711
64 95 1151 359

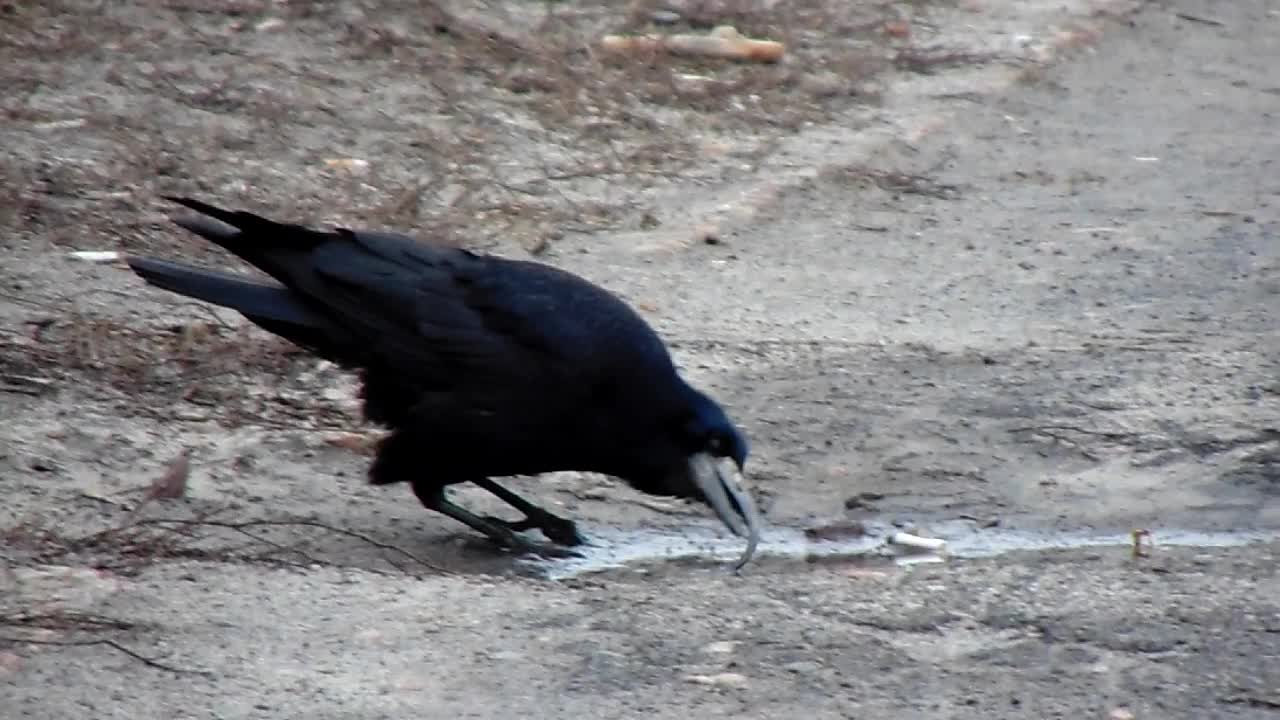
0 0 1280 719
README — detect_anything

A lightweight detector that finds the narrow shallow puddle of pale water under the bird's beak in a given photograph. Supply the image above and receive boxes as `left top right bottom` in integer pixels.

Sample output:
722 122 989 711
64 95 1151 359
521 521 1280 579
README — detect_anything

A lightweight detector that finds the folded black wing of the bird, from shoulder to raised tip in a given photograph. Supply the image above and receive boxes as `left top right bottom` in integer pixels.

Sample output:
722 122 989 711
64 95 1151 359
147 199 675 429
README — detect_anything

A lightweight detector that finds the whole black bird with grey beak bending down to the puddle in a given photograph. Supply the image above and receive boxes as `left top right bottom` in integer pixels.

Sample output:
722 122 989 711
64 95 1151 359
128 196 759 568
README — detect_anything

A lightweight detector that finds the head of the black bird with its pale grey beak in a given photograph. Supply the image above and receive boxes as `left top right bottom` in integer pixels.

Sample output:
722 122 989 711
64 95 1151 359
678 388 760 569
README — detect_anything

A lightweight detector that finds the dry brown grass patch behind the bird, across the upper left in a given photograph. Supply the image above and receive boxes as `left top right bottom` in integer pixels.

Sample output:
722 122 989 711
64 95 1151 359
0 0 952 255
